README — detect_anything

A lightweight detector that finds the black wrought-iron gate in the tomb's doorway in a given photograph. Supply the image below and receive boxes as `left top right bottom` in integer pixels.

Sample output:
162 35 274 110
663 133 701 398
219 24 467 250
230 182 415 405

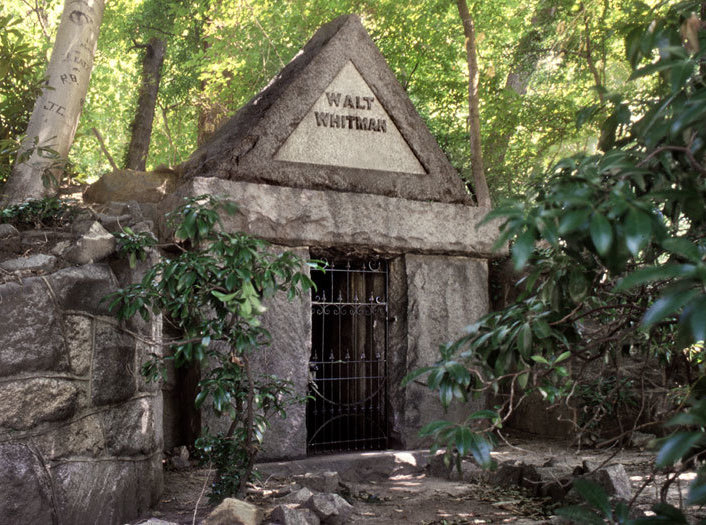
307 260 388 454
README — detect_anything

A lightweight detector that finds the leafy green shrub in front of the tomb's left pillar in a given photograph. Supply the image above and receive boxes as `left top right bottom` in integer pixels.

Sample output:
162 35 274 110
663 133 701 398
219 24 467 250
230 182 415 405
106 196 313 500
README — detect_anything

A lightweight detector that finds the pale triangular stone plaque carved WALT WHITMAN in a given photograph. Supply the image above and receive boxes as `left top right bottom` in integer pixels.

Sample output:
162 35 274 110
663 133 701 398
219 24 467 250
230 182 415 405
275 60 426 175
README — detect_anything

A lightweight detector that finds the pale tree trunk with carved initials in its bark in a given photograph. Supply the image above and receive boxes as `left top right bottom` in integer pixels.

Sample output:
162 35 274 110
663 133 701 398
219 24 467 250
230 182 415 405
2 0 105 204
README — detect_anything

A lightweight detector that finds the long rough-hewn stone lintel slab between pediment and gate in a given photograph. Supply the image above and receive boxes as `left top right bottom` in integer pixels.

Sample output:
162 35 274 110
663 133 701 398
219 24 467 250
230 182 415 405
160 177 499 258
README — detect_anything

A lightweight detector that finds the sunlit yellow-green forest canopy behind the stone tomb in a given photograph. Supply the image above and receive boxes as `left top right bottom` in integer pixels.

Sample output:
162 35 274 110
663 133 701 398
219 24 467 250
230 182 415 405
0 0 666 202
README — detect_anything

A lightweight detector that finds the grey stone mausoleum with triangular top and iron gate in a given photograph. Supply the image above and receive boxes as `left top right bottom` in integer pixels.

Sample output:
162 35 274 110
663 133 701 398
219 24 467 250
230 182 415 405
163 16 496 459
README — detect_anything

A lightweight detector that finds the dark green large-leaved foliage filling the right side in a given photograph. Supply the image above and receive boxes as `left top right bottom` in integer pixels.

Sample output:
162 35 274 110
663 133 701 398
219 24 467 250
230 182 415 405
404 4 706 523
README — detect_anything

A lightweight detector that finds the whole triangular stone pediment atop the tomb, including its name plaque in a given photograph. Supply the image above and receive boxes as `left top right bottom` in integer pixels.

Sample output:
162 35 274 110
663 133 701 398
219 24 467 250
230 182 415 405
183 15 470 204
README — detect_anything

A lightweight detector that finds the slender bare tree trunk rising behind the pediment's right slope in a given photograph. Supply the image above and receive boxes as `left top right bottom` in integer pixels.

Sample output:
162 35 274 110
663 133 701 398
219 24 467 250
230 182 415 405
456 0 491 208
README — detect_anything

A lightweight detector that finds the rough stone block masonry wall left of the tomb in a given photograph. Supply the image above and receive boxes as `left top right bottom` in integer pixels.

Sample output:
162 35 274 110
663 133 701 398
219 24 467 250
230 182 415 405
0 206 162 524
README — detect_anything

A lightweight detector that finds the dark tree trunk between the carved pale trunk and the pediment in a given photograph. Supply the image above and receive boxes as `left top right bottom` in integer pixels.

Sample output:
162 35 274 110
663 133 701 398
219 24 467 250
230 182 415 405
125 38 165 171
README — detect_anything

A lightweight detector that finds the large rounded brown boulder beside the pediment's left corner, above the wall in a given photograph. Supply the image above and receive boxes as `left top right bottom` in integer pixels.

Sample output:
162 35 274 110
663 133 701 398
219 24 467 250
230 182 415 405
83 170 178 203
